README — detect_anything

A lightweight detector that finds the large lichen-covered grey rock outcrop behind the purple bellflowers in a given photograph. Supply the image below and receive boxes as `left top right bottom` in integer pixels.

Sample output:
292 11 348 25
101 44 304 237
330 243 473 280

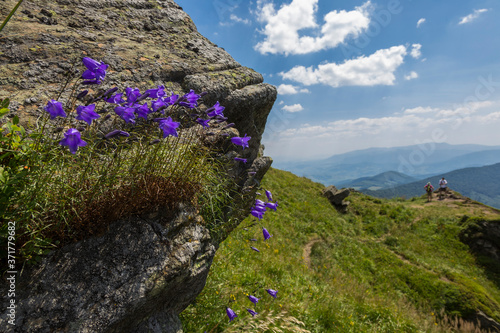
0 0 277 332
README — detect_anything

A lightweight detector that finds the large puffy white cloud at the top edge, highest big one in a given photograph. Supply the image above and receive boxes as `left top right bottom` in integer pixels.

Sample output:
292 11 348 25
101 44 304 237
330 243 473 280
255 0 371 55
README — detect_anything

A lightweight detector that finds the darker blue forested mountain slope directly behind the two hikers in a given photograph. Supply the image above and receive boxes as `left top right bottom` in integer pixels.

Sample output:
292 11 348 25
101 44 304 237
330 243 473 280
362 163 500 208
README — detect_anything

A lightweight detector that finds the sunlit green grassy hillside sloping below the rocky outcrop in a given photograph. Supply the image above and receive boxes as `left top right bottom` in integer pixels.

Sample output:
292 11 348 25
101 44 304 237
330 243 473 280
181 169 500 332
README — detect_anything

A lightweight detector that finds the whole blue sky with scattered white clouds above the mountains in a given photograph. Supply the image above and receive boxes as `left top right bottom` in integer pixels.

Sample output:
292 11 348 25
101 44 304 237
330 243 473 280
177 0 500 162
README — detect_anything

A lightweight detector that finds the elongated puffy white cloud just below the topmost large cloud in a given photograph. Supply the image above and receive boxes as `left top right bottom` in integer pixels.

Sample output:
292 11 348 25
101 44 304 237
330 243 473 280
279 45 406 87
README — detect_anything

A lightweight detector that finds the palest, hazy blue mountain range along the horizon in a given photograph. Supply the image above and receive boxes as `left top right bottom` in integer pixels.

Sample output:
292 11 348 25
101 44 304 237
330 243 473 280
274 143 500 187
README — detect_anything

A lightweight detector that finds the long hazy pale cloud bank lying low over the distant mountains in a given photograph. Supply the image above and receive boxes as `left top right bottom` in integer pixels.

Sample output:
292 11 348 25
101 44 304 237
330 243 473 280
264 101 500 159
